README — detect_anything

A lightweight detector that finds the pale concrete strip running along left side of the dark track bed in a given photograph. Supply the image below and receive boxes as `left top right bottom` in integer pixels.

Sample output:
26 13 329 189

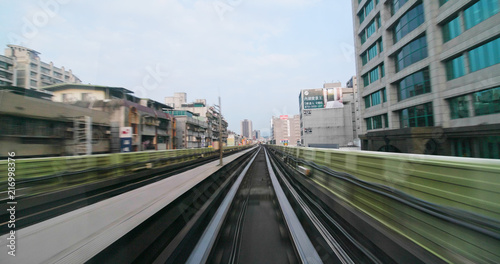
0 146 253 264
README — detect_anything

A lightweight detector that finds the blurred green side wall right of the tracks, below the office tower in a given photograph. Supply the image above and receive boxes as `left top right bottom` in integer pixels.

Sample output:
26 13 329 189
270 146 500 263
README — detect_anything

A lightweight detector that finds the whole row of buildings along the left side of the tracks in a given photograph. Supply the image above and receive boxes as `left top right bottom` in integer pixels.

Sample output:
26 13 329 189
0 45 236 157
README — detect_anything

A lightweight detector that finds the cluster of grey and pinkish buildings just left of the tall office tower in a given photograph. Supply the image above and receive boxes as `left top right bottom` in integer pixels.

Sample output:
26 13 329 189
271 76 359 149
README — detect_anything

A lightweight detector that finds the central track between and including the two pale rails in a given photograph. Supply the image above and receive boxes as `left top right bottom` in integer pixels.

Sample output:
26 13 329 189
187 148 322 263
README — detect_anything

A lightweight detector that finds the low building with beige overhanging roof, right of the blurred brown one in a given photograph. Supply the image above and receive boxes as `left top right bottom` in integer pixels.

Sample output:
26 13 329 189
43 84 175 152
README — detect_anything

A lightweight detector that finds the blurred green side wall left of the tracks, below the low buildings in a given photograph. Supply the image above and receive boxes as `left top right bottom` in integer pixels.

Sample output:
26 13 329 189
0 146 250 198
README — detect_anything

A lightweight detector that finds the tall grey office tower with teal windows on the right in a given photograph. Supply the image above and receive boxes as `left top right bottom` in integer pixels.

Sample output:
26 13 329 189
352 0 500 158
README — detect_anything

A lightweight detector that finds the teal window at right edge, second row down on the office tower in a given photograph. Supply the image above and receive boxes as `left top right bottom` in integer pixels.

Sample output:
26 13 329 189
469 38 500 72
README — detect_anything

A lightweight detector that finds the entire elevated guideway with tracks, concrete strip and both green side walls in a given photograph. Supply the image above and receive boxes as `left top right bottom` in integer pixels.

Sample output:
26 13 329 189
0 145 500 263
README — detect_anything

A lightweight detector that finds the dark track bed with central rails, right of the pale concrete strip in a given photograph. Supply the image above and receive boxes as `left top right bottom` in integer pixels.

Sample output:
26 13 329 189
88 147 378 263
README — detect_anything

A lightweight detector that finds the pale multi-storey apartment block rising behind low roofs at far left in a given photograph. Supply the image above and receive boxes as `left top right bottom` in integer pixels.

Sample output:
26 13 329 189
0 45 81 89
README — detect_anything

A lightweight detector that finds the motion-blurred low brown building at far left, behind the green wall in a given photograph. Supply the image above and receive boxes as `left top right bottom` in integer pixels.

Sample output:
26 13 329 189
0 86 111 157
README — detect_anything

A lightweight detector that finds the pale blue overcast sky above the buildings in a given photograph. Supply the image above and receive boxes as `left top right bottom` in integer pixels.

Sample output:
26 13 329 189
0 0 355 133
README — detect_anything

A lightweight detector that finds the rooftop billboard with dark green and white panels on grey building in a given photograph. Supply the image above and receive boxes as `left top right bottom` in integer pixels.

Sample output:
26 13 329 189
302 87 344 109
